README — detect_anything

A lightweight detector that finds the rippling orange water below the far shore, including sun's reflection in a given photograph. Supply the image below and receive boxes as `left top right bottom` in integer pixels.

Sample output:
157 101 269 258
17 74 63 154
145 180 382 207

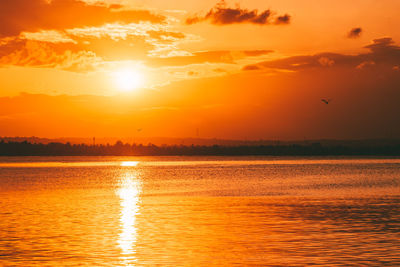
0 157 400 266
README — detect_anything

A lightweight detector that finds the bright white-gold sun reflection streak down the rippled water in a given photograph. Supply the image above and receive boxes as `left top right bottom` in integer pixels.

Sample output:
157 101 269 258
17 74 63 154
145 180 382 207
117 161 141 266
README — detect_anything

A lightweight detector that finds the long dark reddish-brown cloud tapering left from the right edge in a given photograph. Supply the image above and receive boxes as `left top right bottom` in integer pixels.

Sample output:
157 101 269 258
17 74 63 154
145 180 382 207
243 37 400 71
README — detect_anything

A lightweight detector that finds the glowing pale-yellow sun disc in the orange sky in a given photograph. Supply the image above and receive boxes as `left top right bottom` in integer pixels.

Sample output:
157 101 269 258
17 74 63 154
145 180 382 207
113 69 143 92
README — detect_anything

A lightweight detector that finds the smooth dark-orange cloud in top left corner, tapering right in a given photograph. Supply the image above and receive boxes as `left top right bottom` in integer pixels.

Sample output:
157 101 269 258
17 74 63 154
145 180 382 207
0 0 165 37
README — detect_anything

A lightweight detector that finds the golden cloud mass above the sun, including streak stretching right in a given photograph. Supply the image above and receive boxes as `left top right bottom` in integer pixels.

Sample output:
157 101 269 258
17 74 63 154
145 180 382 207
0 0 280 86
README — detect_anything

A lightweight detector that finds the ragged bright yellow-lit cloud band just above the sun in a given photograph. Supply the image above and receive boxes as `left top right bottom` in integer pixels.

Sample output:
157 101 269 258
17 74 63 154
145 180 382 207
0 22 199 71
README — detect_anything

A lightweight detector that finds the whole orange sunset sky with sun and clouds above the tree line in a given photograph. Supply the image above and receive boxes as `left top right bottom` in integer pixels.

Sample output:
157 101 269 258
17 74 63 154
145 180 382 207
0 0 400 140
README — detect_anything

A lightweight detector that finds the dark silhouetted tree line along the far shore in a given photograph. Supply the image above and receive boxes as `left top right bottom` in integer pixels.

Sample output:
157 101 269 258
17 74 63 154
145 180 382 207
0 141 400 156
